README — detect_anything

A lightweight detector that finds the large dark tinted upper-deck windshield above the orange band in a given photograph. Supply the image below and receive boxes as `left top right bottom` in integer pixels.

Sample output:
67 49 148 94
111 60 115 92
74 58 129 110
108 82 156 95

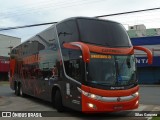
77 19 131 47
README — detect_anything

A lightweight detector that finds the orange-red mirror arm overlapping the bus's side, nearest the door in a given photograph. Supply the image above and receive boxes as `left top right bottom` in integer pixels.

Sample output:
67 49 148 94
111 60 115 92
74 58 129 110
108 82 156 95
63 42 90 63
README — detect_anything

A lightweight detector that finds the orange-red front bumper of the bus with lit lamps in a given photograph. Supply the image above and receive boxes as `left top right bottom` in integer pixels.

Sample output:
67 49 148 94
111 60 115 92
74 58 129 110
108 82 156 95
82 95 139 112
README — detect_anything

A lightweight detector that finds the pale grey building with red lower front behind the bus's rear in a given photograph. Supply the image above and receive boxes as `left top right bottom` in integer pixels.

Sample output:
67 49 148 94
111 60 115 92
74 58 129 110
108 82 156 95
0 34 21 81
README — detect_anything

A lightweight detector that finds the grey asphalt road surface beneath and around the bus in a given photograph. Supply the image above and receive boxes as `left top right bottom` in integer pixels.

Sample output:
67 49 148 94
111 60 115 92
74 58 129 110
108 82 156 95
0 83 160 120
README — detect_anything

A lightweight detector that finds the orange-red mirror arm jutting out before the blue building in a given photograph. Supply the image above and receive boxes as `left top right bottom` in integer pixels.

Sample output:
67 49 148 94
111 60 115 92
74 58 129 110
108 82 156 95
133 46 153 64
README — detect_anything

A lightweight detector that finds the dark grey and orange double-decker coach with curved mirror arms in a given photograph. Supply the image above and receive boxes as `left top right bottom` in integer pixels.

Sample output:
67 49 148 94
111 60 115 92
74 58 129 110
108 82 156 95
10 17 152 112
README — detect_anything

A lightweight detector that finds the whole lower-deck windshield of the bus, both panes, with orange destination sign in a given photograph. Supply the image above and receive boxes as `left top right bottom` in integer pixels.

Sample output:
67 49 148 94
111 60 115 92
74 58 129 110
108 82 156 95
86 54 136 86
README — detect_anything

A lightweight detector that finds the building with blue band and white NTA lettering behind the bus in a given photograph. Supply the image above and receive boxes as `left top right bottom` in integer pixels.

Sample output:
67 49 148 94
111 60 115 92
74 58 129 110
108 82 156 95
128 25 160 84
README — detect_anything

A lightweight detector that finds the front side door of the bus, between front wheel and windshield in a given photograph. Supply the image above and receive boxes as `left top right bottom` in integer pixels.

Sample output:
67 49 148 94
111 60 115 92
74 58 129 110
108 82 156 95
62 49 84 110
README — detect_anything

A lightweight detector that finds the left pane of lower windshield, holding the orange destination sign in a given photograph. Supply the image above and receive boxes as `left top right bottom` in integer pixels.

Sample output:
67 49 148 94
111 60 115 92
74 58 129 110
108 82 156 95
87 54 116 85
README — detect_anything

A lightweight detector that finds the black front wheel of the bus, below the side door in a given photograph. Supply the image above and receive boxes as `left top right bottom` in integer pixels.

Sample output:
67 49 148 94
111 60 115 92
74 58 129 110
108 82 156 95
54 90 64 112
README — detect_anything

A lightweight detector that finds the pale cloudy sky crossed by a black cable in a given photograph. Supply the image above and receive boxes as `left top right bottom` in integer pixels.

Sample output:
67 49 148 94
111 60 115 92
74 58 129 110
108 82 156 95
0 0 160 42
